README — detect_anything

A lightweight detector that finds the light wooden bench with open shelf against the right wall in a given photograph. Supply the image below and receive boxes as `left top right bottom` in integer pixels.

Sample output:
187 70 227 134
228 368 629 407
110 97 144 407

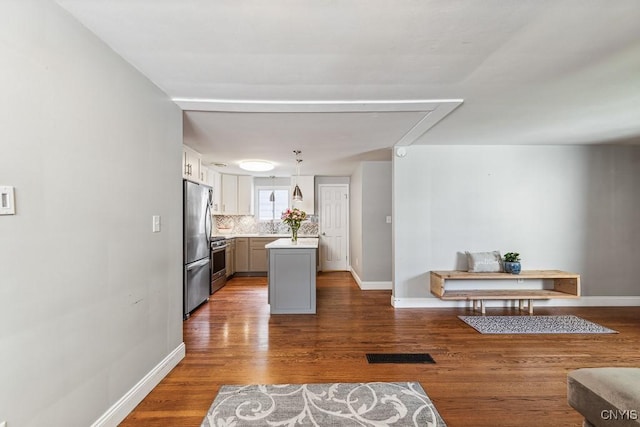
431 270 580 314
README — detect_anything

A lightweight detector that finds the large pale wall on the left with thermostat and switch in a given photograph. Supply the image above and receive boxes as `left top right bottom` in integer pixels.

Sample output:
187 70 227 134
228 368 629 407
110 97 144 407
0 0 182 427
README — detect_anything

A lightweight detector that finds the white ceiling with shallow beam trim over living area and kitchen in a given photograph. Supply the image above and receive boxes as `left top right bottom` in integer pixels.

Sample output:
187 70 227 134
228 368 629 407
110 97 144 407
57 0 640 176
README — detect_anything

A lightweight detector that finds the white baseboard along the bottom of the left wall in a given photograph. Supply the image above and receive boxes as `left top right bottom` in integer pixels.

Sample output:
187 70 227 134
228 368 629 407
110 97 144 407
91 343 186 427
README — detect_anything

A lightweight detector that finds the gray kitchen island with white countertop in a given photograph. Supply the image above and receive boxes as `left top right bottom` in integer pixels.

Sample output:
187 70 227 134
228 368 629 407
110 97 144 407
265 238 318 314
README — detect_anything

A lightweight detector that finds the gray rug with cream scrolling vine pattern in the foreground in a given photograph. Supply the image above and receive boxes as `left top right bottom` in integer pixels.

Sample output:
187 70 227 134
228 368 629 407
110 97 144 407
201 382 446 427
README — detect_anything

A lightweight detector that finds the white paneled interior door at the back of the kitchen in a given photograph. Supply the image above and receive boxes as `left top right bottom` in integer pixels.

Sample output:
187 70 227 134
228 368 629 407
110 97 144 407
318 184 349 271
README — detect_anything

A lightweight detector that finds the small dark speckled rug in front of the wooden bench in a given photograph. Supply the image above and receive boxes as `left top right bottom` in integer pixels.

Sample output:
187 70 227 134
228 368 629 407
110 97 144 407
458 316 618 334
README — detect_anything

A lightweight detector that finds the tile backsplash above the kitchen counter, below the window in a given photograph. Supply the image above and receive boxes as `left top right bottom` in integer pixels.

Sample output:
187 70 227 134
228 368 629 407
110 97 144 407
213 215 318 235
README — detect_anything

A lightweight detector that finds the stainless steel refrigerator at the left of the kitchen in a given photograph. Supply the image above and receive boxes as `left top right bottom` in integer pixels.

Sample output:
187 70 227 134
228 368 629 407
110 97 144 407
183 180 213 319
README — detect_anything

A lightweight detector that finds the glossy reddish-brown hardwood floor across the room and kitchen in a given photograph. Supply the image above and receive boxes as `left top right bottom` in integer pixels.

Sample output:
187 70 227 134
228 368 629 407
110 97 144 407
121 272 640 427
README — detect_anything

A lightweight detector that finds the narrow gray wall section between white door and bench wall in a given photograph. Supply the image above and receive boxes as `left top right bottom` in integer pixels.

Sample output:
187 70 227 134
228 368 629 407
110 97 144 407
350 162 392 282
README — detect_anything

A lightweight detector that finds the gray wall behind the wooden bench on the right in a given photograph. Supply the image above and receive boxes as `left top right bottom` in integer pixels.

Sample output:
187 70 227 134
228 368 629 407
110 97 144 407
393 146 640 298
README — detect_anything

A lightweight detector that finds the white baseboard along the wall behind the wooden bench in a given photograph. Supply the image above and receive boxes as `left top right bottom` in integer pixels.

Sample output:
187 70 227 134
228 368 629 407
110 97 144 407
391 295 640 308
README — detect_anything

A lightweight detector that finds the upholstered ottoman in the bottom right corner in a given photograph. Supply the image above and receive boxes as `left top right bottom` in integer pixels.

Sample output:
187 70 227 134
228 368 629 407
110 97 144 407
567 368 640 427
